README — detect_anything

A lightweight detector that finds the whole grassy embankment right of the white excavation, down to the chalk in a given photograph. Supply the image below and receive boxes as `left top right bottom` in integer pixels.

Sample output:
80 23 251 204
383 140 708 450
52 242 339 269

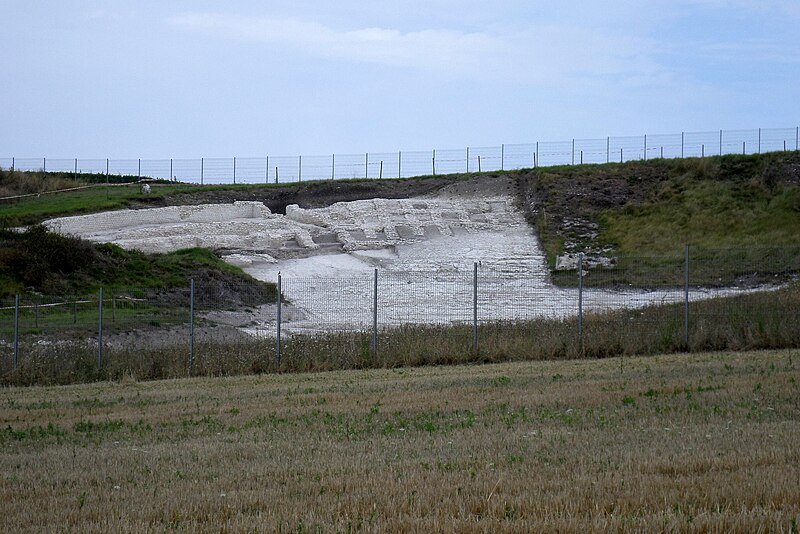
520 152 800 285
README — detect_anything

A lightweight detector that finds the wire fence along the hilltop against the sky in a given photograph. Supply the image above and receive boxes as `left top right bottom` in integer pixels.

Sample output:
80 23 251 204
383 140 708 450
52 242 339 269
0 127 800 184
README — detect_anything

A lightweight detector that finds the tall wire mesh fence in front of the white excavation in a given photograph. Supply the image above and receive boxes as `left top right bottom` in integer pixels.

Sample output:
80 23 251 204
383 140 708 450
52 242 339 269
0 245 800 384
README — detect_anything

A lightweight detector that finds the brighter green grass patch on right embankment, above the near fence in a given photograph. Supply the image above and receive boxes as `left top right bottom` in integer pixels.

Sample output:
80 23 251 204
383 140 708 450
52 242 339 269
600 156 800 253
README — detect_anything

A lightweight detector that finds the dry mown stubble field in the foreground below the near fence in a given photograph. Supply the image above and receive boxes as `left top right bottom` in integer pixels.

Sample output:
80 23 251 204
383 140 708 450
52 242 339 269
0 350 800 532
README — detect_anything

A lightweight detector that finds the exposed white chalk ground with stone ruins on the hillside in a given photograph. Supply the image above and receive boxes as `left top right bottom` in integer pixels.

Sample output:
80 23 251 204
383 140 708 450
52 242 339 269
47 182 768 333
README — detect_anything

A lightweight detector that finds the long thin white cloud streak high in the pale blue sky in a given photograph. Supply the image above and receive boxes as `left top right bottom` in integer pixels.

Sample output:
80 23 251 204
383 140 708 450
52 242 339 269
170 13 667 86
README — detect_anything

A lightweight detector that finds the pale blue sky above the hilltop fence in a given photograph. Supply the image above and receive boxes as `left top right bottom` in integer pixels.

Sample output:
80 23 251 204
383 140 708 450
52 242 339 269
0 0 800 158
